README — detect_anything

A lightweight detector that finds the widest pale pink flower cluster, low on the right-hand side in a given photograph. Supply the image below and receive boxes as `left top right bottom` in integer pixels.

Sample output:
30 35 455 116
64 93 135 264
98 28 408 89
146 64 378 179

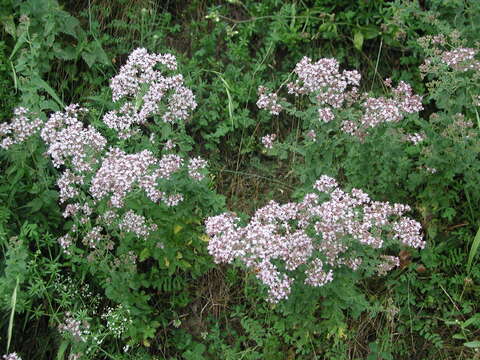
205 176 425 302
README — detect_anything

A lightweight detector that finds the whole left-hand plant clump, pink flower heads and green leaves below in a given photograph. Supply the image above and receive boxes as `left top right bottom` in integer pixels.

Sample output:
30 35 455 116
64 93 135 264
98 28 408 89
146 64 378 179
0 49 221 358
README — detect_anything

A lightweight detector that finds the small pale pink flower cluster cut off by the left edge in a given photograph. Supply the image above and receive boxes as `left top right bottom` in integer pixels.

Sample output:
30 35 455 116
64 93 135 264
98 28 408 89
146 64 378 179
0 107 43 149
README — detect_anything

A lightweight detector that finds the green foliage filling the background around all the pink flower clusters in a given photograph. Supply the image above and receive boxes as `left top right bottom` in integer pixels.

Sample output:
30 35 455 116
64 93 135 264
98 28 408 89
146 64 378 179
0 0 480 360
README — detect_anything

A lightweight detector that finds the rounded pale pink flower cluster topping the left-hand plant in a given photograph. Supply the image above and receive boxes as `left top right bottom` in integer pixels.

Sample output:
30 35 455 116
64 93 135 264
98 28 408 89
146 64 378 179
103 48 197 138
